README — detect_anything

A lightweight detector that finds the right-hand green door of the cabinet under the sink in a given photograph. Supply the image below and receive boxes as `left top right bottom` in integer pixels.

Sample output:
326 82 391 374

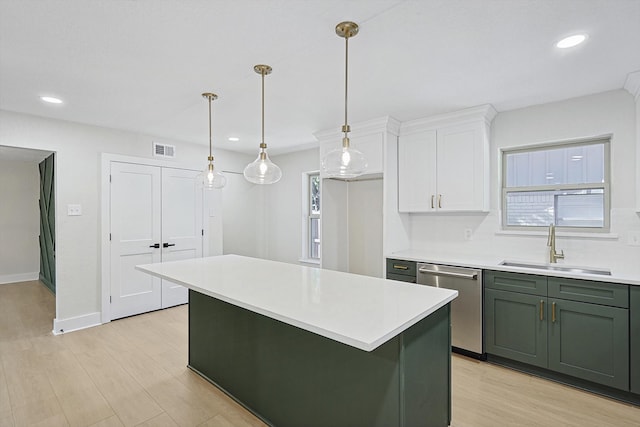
547 298 629 390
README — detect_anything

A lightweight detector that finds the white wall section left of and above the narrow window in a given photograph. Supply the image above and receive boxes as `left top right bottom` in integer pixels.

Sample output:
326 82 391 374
262 148 322 263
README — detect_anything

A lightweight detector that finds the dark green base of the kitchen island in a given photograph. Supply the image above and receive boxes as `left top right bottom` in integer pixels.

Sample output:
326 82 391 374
189 290 451 427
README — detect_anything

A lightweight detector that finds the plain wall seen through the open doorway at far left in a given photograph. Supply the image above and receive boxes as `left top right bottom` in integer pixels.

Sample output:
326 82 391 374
0 159 40 283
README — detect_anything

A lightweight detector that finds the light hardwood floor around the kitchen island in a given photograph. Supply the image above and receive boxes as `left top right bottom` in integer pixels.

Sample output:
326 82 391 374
0 282 640 427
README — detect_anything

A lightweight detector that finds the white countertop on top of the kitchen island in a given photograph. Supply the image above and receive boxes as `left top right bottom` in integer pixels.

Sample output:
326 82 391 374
136 255 458 351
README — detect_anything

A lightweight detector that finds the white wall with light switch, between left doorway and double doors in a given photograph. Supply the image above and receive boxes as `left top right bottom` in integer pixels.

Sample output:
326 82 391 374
0 111 252 328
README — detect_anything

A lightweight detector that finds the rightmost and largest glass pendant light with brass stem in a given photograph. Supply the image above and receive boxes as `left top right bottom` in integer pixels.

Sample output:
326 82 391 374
322 21 367 178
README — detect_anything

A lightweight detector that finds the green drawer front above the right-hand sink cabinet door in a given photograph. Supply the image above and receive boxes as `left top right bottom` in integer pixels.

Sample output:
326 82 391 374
548 277 629 308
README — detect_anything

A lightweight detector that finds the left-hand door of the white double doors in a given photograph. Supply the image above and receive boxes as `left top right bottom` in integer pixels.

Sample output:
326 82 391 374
110 162 162 319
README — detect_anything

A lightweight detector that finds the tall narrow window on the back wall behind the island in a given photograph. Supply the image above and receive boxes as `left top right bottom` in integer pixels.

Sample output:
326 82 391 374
302 172 320 263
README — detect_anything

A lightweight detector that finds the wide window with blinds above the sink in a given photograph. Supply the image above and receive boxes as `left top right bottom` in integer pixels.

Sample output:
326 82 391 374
502 139 609 231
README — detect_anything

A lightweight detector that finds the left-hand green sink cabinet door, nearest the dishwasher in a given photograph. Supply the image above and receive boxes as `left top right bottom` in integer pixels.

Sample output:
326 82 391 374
484 289 547 368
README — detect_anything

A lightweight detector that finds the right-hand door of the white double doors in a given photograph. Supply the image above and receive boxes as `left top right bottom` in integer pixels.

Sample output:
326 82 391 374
161 168 203 308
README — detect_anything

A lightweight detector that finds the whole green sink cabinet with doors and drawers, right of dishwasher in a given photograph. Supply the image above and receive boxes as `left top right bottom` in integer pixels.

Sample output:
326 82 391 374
484 271 640 394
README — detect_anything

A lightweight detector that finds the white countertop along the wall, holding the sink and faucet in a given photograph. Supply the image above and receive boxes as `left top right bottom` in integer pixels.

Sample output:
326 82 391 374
386 249 640 285
